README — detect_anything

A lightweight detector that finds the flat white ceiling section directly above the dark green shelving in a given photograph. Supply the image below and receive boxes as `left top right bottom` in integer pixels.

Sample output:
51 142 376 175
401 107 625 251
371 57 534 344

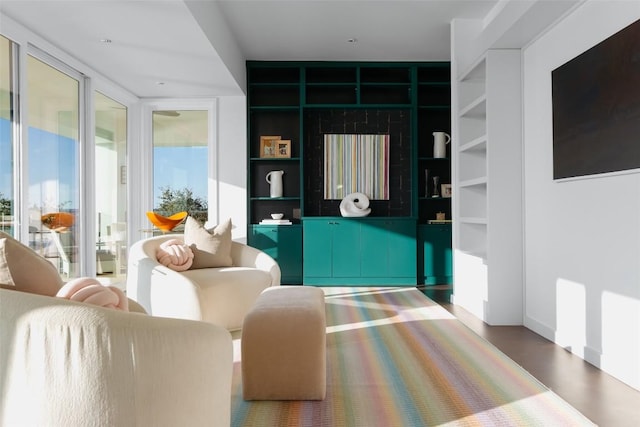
220 0 497 61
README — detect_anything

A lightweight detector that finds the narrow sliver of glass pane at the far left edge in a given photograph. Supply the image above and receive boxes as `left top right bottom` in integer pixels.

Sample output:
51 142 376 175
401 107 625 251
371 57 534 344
0 36 15 235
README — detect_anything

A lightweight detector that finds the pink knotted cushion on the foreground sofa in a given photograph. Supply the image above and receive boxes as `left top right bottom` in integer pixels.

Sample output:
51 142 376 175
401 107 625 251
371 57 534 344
56 277 129 311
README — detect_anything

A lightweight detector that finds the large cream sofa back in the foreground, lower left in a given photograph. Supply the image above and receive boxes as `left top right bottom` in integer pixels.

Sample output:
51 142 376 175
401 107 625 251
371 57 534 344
0 289 233 427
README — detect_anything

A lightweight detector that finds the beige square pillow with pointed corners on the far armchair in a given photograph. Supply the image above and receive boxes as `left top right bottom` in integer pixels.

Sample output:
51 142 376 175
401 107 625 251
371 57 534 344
184 216 232 270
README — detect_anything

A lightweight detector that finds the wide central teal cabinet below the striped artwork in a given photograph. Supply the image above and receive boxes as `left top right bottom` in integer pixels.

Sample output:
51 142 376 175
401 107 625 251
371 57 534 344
303 217 416 286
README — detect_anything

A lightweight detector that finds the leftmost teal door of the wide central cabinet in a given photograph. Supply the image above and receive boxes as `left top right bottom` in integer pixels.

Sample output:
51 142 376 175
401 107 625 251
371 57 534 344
302 220 332 277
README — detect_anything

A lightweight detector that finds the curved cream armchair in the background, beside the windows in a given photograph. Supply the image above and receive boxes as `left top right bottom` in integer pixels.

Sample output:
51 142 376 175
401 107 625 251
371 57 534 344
127 234 280 331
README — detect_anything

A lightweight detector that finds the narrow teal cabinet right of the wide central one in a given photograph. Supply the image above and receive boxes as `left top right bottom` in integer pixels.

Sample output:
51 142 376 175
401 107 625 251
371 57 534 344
418 224 453 285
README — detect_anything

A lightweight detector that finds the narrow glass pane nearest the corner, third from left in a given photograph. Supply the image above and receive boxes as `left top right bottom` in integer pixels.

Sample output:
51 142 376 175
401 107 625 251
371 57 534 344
94 92 128 283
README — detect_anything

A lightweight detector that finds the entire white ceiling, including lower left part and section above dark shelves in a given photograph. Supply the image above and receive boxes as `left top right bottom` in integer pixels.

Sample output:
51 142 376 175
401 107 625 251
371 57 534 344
0 0 498 97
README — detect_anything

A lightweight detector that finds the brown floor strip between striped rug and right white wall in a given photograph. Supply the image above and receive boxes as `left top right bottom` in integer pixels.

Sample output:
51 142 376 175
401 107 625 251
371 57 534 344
422 286 640 427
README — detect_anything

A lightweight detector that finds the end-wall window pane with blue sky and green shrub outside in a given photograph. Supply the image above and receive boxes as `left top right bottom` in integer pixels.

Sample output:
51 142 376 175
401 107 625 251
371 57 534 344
152 110 209 229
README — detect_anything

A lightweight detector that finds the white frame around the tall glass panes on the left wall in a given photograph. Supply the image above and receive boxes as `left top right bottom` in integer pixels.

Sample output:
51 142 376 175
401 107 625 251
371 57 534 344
0 15 140 277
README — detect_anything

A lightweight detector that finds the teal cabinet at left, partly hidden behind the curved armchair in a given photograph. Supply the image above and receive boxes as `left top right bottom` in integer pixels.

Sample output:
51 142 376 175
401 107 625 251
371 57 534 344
249 225 302 285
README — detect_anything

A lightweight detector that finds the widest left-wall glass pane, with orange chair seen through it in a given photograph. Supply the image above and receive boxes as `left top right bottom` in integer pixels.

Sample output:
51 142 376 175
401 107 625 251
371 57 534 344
26 55 82 278
